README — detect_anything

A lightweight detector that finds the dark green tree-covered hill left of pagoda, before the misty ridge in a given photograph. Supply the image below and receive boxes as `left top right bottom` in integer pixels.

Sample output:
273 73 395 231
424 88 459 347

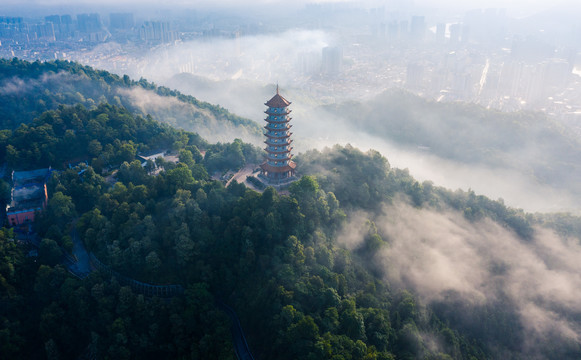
0 103 262 173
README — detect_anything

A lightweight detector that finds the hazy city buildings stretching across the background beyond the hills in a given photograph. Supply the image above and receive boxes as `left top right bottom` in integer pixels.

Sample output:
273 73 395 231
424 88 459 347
0 3 581 128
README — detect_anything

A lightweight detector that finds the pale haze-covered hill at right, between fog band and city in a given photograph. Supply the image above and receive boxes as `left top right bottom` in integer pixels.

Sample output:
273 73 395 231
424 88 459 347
326 89 581 199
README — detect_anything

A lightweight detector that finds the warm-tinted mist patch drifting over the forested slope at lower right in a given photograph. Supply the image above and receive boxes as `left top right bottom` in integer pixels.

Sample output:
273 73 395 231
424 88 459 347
338 199 581 359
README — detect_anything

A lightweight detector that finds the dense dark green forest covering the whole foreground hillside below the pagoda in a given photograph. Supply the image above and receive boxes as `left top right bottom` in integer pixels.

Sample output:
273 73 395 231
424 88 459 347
0 59 581 360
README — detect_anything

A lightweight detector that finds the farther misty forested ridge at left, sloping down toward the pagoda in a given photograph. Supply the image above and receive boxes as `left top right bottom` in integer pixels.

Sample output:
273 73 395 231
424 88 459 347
0 58 262 142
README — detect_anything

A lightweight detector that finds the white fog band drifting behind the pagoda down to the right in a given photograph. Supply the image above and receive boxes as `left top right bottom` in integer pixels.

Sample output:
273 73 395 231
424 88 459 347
98 30 579 212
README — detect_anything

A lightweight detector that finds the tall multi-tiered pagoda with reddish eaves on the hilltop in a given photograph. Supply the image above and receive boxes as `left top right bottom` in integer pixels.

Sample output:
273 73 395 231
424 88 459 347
260 86 297 185
